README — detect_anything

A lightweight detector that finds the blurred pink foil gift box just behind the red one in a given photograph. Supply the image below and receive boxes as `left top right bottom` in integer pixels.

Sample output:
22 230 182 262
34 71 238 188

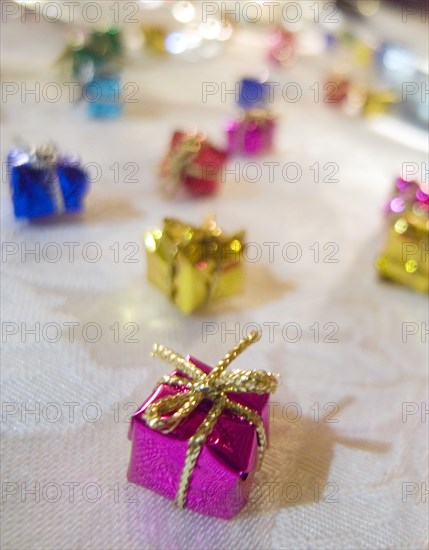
226 110 276 156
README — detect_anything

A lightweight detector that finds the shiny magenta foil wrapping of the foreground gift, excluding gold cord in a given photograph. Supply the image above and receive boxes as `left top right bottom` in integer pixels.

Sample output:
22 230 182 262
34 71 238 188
128 356 269 519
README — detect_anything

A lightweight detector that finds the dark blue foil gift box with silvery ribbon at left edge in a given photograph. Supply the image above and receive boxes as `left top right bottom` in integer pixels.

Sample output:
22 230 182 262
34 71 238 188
7 145 89 219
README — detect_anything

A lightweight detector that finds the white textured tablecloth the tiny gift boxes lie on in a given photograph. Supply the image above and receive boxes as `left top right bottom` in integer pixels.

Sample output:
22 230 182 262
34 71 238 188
2 8 428 549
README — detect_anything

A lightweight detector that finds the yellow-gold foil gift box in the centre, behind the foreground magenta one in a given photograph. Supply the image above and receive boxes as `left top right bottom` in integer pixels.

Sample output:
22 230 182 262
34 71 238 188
145 218 244 313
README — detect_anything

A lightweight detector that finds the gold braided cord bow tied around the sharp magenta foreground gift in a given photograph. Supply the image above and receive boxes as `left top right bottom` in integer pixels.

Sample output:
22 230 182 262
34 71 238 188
143 331 278 508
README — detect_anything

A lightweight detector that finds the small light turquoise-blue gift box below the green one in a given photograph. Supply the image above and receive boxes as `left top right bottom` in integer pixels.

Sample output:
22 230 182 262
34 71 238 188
84 75 123 118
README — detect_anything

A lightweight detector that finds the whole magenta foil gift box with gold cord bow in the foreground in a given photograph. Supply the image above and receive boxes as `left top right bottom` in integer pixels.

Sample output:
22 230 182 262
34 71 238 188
128 333 277 519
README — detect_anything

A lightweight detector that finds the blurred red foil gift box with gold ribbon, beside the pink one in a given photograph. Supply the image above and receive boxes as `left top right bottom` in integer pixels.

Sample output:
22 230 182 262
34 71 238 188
161 131 227 196
